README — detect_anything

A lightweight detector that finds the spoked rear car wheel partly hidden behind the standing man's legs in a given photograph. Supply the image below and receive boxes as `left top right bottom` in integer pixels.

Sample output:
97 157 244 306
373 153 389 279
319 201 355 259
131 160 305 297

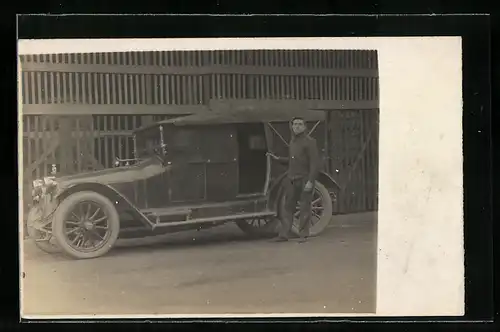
280 181 333 236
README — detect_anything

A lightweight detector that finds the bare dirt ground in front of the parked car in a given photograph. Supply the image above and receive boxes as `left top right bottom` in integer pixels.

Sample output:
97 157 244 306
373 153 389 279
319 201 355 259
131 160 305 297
22 214 376 318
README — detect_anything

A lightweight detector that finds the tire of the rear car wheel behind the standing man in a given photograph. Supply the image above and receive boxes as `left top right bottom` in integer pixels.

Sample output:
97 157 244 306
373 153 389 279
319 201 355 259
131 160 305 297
280 181 333 236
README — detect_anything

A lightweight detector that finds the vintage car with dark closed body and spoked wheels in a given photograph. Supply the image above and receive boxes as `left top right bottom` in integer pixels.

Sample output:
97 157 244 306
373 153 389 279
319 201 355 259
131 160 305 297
27 110 339 259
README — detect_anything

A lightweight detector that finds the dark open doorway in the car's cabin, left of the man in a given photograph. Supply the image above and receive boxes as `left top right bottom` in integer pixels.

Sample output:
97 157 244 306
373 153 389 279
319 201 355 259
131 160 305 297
237 123 267 195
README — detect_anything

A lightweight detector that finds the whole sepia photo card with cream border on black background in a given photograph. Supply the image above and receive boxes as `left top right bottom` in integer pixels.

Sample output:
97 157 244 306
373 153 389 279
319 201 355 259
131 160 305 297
18 38 463 319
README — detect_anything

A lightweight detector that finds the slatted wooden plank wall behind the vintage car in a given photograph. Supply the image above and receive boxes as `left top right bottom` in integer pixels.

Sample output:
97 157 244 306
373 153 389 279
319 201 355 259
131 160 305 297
20 50 379 211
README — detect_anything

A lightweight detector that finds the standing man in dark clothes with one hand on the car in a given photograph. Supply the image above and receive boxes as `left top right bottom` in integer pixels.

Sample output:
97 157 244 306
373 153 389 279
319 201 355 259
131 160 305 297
268 117 319 242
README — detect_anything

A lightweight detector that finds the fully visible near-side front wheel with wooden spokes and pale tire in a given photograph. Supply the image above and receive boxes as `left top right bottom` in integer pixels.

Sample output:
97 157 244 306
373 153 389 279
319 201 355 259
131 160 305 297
52 191 120 259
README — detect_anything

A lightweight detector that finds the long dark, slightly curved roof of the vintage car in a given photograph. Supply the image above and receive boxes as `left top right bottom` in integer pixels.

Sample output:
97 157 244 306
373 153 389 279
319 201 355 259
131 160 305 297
137 108 325 131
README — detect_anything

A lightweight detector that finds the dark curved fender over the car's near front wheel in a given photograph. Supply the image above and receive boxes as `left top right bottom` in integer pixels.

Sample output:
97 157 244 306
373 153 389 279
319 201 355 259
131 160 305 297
56 182 153 228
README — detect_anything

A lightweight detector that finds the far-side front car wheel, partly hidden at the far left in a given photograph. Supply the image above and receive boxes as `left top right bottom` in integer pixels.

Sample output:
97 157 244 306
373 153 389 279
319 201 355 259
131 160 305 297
26 207 61 254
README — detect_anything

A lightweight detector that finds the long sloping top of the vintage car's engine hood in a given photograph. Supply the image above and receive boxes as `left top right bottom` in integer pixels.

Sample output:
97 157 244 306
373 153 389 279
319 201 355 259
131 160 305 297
55 158 165 189
